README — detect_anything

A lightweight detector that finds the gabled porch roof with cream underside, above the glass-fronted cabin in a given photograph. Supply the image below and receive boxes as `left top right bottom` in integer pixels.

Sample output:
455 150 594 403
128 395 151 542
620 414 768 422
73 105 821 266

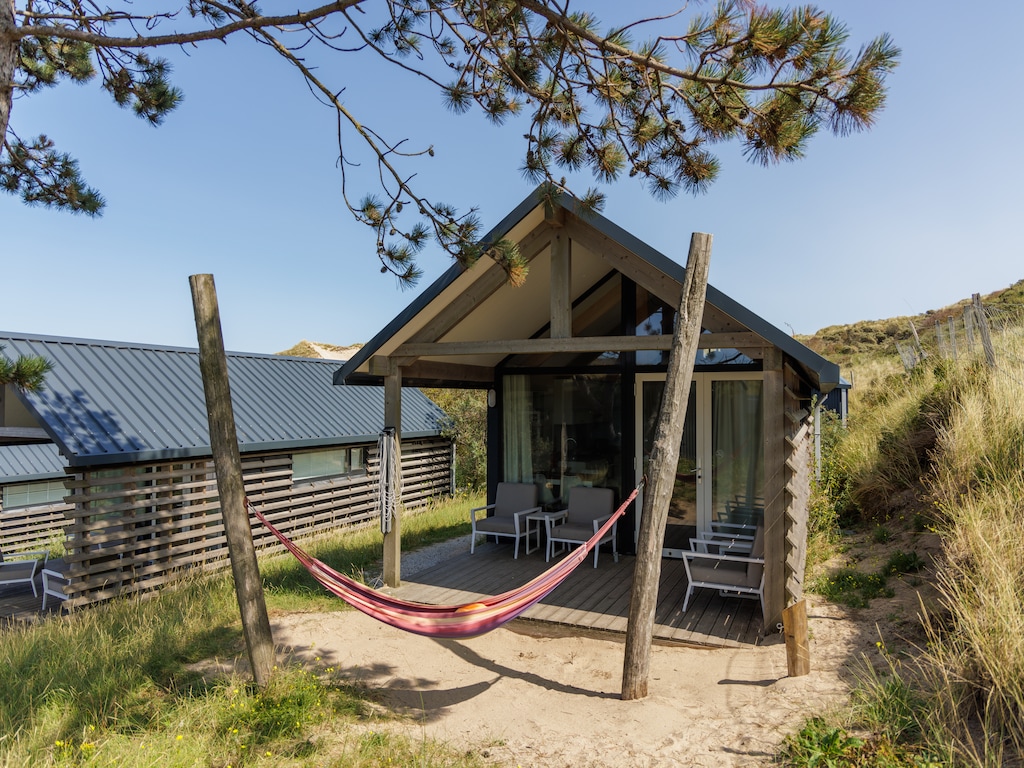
334 189 840 392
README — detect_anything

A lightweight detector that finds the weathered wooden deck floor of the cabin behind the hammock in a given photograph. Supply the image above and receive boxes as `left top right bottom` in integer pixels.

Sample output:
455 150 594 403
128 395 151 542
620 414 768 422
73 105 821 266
394 544 761 647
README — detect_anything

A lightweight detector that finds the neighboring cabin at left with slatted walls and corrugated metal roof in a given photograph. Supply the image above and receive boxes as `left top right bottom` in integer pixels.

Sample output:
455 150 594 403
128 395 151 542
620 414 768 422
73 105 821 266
0 334 454 605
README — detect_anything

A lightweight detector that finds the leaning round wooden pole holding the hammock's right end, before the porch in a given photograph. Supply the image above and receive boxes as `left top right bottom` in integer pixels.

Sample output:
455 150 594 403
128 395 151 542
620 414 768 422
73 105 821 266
623 232 712 700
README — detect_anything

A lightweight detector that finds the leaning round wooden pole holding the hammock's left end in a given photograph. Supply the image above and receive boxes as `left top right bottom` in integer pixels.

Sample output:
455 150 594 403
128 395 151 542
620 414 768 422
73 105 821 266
188 274 274 688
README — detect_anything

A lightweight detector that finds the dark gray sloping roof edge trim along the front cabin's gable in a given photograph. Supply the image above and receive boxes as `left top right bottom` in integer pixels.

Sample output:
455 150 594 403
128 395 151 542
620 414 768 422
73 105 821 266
334 187 840 392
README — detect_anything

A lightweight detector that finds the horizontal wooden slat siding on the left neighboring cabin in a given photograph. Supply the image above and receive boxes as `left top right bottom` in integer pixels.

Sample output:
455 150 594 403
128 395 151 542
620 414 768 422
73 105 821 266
58 438 452 608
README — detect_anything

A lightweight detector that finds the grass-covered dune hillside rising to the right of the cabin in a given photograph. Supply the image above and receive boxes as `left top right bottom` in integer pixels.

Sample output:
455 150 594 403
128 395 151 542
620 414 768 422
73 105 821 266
782 281 1024 768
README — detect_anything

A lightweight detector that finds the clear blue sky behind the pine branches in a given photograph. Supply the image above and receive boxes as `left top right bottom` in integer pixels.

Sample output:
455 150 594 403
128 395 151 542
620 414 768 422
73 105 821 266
0 0 1024 352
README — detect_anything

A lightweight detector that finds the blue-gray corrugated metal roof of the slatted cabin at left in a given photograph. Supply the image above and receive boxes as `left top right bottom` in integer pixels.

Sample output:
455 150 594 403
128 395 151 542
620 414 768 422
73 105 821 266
0 333 442 473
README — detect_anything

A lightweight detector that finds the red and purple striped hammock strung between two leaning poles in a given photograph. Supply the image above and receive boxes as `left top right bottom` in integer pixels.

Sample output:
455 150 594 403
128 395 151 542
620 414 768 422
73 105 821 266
246 481 643 638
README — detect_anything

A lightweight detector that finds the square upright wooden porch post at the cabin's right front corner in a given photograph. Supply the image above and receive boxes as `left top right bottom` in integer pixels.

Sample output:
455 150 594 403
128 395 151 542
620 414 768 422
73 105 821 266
761 347 786 634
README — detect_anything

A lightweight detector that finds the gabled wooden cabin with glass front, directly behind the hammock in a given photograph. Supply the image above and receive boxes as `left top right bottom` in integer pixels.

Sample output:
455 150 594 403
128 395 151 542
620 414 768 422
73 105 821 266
335 191 840 627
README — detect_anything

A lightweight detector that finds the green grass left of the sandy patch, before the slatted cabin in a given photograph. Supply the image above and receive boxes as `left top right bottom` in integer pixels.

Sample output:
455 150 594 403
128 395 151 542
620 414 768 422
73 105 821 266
0 499 482 768
